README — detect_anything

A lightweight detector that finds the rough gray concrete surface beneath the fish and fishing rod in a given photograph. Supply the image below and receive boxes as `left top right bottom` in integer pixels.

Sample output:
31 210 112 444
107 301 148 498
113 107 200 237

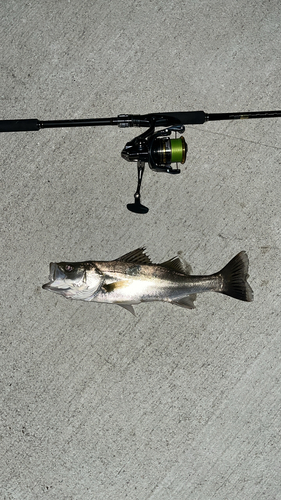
0 0 281 500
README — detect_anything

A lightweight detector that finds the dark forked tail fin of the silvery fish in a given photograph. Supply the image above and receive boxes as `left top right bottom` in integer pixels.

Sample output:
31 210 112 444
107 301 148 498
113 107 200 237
217 252 254 302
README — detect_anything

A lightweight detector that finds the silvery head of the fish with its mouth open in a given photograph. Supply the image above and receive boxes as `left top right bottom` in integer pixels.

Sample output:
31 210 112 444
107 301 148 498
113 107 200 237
42 262 102 300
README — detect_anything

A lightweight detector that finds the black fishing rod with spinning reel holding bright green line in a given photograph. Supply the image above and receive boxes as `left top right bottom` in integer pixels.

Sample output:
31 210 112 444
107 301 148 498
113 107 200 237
0 110 281 214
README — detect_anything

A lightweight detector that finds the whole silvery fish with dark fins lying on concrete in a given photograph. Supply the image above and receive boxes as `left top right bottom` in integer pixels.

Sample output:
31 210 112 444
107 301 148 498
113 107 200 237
42 247 253 315
